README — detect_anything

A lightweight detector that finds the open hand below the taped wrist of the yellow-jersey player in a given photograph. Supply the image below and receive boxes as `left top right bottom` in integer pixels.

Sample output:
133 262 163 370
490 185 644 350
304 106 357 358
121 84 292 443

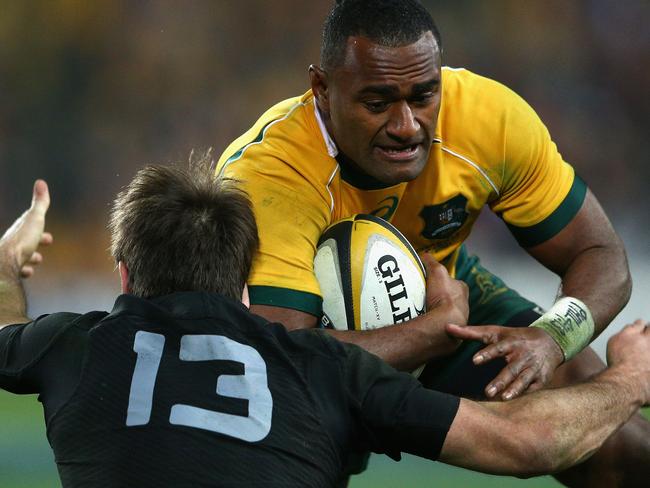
440 324 564 400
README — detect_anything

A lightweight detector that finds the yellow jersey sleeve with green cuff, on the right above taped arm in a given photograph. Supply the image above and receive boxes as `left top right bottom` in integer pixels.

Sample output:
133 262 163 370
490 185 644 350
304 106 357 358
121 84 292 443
490 90 586 247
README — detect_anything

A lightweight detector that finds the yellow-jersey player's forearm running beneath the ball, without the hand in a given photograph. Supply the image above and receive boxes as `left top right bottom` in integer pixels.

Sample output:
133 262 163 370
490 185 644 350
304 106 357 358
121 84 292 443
328 304 460 371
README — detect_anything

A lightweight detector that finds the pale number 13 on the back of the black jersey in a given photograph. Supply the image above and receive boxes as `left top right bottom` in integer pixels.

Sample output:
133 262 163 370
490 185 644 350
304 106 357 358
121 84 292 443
126 331 273 442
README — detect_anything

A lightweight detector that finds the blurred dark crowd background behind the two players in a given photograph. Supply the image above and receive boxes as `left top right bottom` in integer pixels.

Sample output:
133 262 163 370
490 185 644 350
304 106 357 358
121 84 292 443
0 0 650 486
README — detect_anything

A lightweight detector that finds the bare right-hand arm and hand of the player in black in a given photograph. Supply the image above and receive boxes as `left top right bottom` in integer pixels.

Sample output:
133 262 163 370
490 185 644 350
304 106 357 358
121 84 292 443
440 320 650 476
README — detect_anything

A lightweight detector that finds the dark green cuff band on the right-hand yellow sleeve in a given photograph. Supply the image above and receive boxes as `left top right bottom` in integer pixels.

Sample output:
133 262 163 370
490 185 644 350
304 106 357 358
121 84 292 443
506 174 587 247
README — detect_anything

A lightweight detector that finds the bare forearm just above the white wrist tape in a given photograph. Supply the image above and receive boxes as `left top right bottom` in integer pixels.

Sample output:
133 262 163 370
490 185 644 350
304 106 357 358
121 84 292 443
560 242 632 338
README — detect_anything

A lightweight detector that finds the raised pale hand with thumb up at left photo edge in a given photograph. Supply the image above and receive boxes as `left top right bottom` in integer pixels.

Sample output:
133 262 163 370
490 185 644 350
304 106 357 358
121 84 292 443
0 180 52 278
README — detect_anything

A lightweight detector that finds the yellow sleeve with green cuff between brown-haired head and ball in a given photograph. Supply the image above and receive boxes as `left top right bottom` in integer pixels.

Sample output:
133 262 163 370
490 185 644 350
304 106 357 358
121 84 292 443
217 141 331 316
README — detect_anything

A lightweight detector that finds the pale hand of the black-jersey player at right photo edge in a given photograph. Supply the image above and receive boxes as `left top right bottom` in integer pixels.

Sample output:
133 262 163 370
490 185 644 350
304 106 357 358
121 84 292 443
607 320 650 405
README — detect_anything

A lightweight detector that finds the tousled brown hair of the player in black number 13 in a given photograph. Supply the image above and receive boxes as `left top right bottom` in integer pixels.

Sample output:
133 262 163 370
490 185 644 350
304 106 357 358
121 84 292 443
109 153 259 300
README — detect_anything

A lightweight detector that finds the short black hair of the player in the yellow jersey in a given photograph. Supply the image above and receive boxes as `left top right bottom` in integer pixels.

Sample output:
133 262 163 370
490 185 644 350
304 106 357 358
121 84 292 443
320 0 442 70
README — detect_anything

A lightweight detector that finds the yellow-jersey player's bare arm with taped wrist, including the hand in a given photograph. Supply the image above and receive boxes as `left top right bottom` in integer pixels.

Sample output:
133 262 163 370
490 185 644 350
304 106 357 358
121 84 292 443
466 193 632 399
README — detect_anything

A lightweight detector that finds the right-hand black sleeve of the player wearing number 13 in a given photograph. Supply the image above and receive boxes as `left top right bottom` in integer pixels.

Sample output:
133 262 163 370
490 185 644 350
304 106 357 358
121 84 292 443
344 344 460 460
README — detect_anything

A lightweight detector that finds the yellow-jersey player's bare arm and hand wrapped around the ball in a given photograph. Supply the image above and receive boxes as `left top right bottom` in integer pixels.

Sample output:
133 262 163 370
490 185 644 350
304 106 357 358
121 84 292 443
251 254 469 371
